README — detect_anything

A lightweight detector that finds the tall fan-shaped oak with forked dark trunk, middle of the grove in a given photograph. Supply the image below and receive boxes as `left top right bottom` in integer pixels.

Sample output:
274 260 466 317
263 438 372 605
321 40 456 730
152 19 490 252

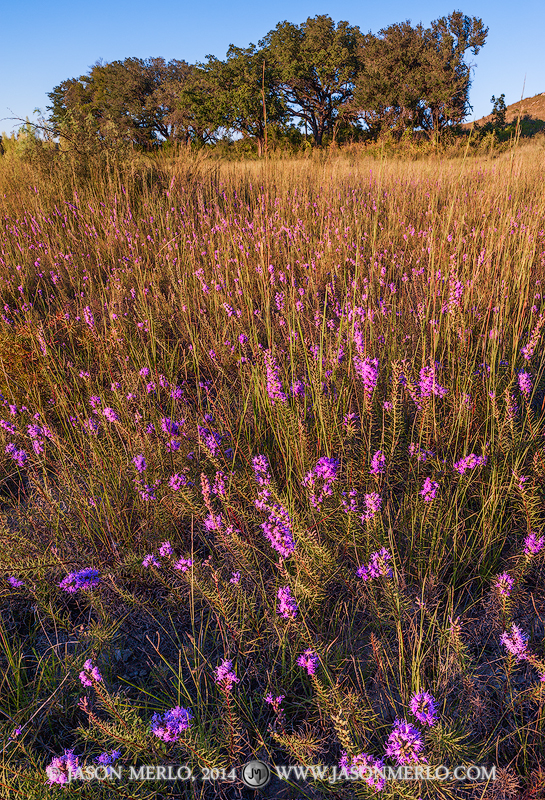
259 14 361 145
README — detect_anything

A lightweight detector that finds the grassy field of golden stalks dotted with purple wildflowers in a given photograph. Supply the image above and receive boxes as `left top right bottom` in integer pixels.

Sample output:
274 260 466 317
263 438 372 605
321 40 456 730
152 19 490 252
0 147 545 800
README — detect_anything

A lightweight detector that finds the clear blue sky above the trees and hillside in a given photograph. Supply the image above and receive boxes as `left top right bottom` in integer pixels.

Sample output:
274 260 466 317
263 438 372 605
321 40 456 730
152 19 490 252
0 0 545 132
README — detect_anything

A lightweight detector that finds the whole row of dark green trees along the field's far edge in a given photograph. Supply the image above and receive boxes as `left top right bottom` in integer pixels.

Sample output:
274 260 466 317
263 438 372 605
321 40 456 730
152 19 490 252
48 11 488 153
